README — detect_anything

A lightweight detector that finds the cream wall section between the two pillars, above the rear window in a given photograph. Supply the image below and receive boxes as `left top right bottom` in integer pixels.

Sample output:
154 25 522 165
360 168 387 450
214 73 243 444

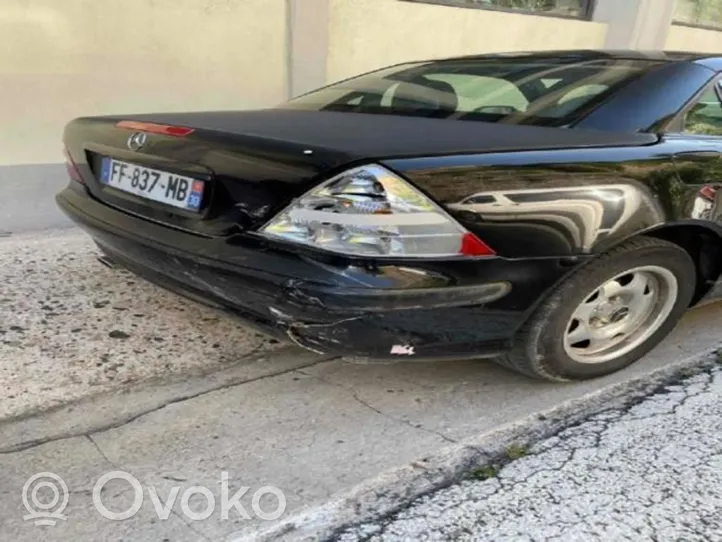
327 0 607 81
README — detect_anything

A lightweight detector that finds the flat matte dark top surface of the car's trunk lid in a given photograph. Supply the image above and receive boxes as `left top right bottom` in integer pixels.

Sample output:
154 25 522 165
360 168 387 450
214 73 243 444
121 108 657 160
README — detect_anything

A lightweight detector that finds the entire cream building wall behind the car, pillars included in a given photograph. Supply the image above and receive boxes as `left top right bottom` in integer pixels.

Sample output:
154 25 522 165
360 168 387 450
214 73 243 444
0 0 722 172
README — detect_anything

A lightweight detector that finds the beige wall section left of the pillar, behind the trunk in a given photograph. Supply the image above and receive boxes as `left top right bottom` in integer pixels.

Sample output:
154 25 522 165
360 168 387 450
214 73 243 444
0 0 286 165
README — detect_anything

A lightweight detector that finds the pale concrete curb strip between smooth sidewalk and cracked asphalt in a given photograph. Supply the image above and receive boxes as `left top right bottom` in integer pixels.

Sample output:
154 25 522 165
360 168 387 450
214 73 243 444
226 343 722 542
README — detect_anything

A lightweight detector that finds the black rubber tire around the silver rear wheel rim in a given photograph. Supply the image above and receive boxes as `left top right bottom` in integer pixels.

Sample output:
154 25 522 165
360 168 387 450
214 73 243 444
496 237 697 382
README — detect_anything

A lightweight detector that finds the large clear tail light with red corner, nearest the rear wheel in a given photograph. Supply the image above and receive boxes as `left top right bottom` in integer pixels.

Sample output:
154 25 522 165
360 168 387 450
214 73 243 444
261 165 494 258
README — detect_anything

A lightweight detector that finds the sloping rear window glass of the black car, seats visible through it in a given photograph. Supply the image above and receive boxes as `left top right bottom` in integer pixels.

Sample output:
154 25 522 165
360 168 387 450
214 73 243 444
282 56 660 125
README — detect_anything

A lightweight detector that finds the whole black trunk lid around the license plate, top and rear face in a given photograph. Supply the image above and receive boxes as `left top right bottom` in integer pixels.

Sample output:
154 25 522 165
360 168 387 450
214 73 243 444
64 109 656 236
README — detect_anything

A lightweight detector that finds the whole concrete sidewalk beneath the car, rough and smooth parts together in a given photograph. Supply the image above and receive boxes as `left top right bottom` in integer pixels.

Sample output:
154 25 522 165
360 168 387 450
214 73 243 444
0 231 722 542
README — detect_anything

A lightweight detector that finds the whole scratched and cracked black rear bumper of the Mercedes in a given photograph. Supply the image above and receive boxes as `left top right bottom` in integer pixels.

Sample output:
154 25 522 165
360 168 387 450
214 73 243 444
56 186 560 359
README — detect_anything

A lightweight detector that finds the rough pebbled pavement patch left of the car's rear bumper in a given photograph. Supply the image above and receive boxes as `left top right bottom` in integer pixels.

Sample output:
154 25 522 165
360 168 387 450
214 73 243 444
0 229 281 422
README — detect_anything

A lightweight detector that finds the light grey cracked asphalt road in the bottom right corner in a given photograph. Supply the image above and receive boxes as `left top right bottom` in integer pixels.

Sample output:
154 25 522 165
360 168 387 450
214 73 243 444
338 369 722 542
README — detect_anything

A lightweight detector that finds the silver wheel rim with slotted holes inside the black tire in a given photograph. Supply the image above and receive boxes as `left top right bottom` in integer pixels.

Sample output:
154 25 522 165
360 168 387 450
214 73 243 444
564 265 679 363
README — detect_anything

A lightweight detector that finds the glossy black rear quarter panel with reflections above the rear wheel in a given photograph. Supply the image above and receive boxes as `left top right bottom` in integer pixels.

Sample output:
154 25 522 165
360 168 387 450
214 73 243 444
386 141 722 258
